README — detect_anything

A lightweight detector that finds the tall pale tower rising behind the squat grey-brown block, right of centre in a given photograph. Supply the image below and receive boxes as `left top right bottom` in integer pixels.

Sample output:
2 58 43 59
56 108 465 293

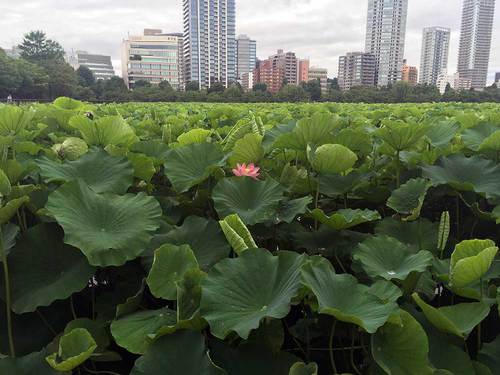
365 0 408 86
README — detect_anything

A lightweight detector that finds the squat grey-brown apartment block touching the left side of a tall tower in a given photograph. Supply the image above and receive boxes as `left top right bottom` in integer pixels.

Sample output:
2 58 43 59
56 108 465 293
338 52 377 90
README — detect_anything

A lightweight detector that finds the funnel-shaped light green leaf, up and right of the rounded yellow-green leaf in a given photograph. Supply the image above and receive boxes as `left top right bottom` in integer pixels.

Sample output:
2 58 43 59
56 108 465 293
375 120 428 151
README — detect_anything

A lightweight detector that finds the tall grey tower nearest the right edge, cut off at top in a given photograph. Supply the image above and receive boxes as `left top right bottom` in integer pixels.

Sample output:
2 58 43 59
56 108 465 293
457 0 495 90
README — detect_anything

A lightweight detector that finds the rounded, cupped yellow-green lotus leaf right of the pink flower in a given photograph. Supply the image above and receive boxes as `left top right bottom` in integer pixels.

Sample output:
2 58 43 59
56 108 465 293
311 144 358 174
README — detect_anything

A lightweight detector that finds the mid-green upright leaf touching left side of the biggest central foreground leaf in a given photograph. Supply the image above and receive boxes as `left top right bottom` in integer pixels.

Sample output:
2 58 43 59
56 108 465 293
146 244 198 300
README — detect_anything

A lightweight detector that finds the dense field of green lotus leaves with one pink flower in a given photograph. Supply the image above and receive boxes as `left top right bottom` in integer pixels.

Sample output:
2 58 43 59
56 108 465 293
0 98 500 375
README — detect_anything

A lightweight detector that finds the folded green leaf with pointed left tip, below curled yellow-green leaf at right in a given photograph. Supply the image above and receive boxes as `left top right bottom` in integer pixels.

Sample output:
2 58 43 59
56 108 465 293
413 293 490 338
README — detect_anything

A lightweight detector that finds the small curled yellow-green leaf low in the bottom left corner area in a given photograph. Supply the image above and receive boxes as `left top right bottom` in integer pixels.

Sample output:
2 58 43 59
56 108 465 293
45 328 97 371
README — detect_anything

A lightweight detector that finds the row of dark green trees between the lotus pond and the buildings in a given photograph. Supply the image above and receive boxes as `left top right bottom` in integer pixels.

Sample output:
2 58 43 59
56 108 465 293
0 31 500 103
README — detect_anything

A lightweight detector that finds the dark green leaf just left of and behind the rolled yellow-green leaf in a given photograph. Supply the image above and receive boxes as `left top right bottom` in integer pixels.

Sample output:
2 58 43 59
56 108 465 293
156 216 230 270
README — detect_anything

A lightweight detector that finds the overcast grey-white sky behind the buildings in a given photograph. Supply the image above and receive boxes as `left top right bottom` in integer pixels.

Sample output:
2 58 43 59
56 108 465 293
0 0 500 81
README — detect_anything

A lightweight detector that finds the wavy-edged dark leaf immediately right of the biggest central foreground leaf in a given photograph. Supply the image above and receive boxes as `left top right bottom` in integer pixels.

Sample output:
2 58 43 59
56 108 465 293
302 258 398 333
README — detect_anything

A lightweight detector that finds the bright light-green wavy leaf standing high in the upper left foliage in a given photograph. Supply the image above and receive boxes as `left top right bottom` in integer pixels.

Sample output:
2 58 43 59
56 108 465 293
69 115 138 147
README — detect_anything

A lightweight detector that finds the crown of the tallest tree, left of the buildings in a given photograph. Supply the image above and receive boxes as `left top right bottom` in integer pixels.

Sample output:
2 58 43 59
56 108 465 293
19 30 64 63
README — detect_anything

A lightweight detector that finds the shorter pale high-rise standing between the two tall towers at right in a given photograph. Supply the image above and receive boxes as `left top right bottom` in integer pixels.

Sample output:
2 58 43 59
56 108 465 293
419 27 450 86
